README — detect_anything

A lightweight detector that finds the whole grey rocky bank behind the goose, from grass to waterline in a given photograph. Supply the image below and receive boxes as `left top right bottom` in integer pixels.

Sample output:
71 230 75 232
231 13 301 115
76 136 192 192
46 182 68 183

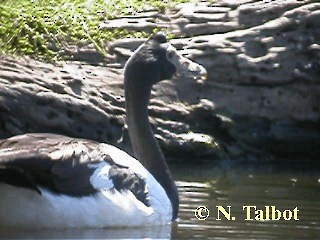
0 0 320 161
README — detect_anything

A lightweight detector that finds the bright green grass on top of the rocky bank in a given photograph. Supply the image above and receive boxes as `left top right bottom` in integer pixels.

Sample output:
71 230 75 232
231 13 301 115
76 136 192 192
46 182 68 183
0 0 192 61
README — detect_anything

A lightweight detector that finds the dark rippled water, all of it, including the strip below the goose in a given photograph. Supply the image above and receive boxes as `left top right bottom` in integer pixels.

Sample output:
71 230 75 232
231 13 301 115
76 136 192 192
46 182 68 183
0 162 320 239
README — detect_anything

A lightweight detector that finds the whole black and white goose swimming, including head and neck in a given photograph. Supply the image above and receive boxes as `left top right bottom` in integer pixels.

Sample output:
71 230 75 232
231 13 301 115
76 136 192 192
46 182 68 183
0 33 205 228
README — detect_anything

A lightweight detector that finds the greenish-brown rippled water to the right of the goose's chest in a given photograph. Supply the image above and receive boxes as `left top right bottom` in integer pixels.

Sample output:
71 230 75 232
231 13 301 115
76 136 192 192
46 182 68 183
172 162 320 239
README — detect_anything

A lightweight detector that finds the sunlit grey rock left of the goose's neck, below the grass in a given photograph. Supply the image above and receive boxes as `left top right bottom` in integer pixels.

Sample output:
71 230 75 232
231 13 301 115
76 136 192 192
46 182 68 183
0 57 125 142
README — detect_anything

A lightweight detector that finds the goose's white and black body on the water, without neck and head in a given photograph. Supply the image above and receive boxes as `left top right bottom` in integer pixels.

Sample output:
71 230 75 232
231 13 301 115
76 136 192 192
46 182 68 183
0 134 172 228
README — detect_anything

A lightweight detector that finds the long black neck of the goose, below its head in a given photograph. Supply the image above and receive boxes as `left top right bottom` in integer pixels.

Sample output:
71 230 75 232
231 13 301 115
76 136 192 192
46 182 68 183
125 77 179 219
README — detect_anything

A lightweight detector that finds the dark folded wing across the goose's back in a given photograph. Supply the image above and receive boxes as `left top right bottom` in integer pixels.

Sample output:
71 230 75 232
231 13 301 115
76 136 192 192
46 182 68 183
0 134 101 196
